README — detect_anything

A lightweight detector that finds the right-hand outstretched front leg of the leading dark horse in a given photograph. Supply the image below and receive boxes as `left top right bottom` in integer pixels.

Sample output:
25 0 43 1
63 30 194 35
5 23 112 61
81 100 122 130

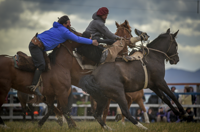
154 82 186 115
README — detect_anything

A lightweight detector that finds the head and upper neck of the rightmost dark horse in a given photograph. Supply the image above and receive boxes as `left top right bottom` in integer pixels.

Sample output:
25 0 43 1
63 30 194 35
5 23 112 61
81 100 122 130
147 28 179 64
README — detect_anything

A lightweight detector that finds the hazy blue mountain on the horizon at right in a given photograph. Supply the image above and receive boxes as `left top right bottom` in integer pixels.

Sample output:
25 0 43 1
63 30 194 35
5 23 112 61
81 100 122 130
165 69 200 83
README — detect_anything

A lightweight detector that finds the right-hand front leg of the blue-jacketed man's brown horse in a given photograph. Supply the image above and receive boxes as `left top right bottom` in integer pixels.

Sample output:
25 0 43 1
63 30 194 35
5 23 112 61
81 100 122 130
57 89 76 128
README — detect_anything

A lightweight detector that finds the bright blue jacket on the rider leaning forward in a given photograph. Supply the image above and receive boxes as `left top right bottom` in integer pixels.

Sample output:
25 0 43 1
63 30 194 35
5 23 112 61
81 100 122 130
37 22 92 51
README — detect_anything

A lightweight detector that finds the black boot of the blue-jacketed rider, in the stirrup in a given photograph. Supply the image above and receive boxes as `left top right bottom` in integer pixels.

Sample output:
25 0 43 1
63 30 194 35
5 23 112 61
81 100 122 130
28 69 42 96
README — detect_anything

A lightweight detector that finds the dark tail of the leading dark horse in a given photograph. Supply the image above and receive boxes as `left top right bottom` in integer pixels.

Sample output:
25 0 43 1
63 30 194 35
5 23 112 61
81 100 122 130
79 75 101 95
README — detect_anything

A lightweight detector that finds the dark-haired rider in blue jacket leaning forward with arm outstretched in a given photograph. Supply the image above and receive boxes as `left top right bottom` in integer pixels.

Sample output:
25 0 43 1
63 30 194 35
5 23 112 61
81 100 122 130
28 15 98 97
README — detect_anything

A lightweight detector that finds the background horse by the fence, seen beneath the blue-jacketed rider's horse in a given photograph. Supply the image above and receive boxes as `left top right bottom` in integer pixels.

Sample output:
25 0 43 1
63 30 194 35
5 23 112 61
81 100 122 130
17 91 34 121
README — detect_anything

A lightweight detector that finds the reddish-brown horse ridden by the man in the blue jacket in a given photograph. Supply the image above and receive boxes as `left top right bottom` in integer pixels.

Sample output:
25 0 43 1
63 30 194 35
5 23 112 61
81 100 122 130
0 32 83 128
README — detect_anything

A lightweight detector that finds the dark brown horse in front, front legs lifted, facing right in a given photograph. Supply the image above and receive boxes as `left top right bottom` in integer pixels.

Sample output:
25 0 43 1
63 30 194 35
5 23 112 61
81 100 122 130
80 29 185 129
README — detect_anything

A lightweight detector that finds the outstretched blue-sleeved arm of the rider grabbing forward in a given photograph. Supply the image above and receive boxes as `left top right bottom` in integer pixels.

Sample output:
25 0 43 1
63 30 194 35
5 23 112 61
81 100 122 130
63 29 92 44
